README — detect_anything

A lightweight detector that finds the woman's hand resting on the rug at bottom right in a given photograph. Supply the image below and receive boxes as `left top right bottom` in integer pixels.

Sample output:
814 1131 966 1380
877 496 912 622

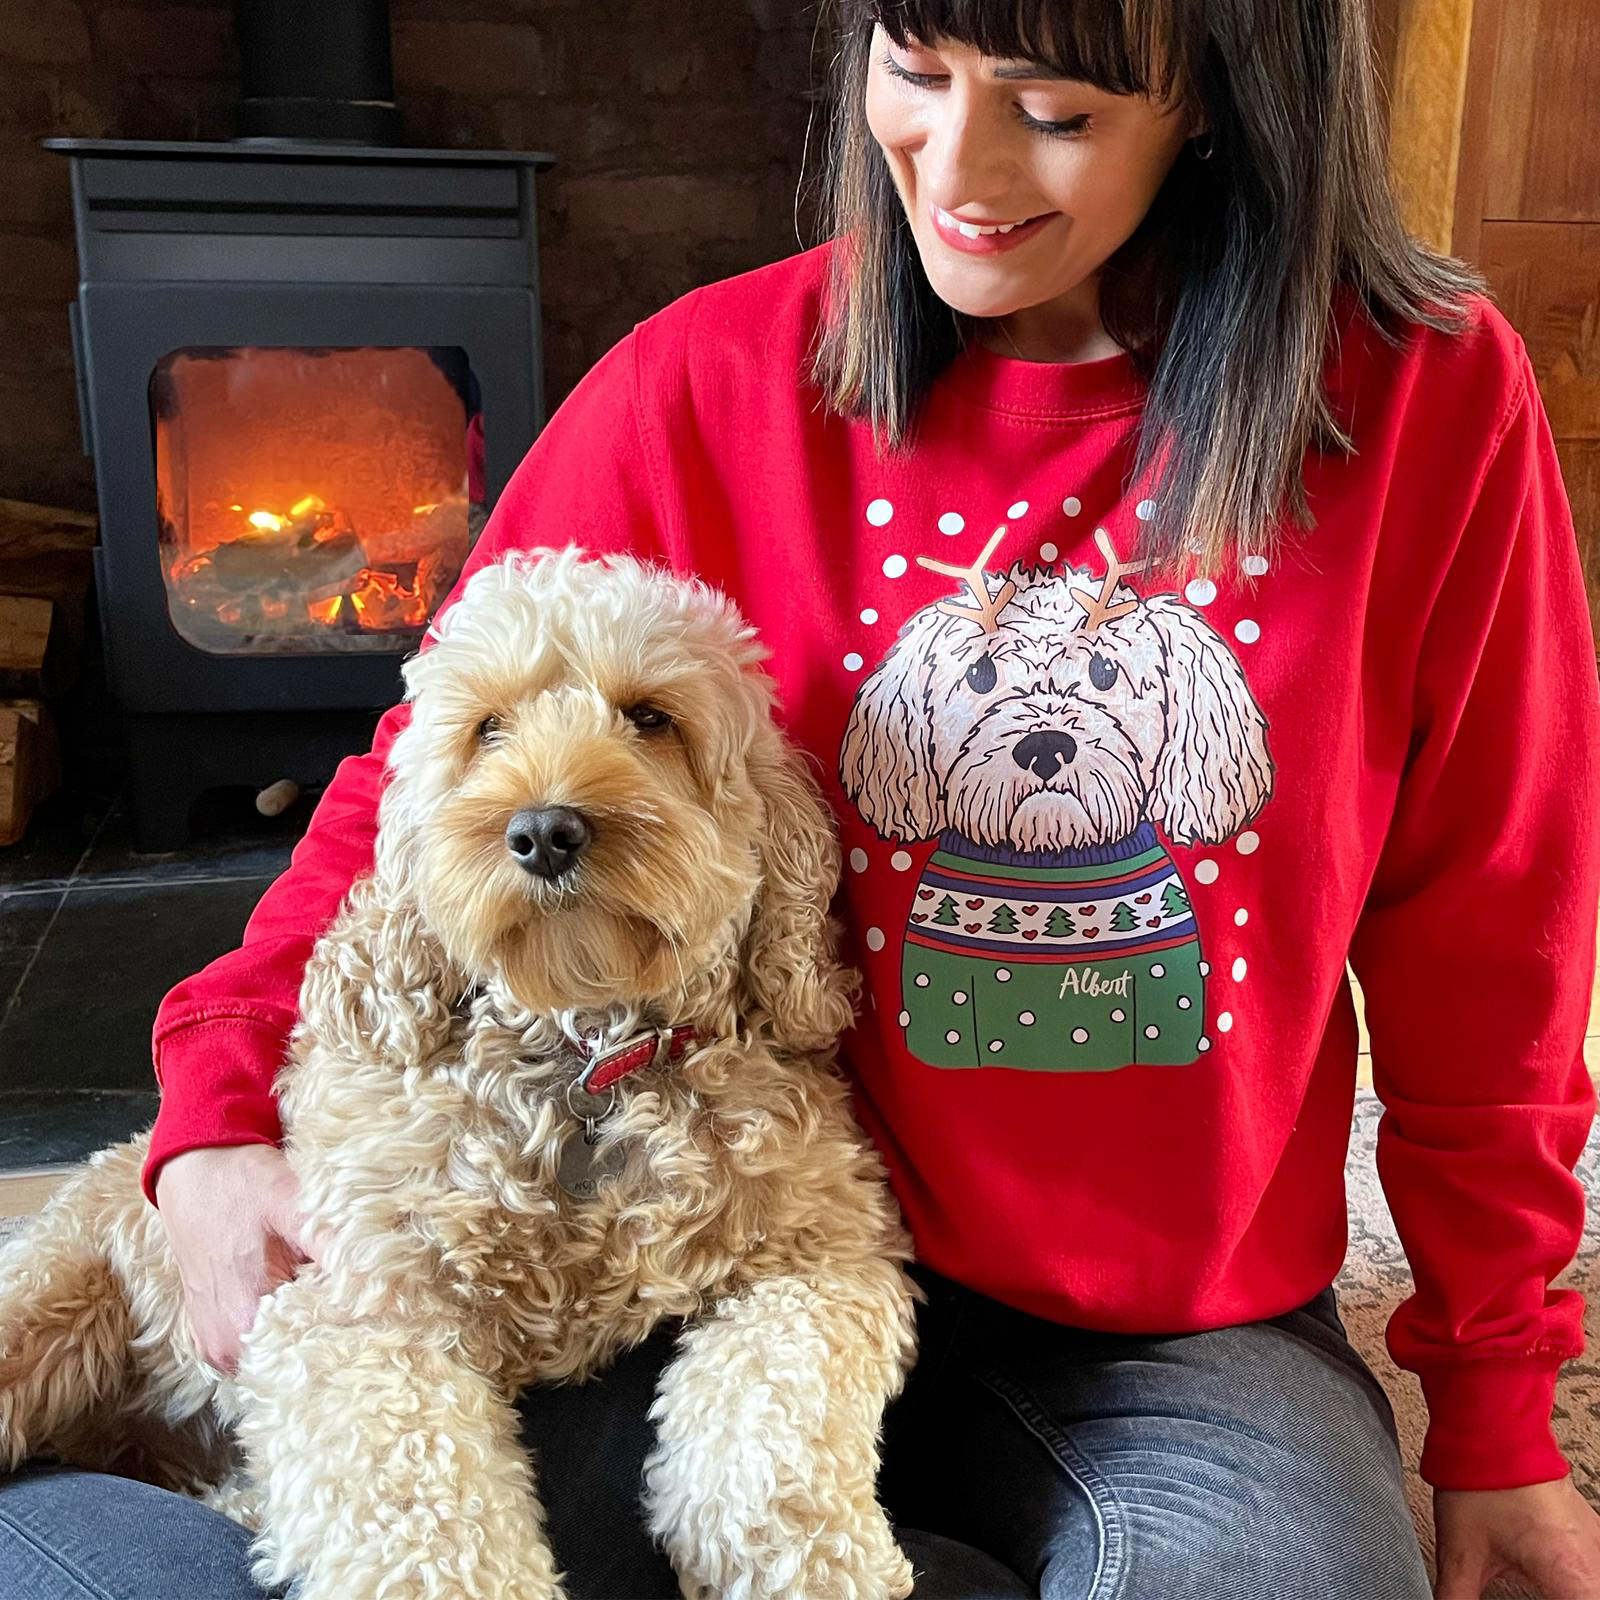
1434 1477 1600 1600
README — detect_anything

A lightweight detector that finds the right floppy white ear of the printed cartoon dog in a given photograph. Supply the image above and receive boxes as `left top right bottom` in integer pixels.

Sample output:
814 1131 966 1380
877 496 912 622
1144 595 1272 845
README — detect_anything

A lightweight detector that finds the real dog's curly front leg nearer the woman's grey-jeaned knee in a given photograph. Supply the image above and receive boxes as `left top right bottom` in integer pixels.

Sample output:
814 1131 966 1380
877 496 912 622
645 1261 915 1600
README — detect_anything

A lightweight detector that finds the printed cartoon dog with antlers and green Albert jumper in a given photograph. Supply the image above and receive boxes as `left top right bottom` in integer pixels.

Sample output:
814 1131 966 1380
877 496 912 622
840 525 1274 1072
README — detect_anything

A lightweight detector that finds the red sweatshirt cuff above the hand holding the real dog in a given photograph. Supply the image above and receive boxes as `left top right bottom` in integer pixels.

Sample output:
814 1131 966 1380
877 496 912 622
141 1016 283 1205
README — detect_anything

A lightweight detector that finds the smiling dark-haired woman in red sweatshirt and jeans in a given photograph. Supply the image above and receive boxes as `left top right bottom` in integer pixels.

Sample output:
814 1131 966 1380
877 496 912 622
0 0 1600 1600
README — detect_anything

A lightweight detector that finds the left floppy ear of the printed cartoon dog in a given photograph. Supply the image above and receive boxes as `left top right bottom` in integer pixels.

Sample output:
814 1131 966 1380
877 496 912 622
838 606 947 842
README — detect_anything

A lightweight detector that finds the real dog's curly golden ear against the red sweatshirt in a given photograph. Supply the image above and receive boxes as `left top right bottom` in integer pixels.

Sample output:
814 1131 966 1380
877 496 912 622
741 725 861 1050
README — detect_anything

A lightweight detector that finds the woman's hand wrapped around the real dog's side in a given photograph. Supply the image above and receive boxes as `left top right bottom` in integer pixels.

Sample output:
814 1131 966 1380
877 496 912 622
155 1144 320 1373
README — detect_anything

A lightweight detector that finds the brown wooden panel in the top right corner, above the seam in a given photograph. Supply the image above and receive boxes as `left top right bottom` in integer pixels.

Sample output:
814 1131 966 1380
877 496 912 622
1483 0 1600 222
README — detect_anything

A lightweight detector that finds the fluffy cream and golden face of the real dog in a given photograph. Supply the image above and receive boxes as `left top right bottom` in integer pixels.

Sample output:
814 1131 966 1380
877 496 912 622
379 549 857 1049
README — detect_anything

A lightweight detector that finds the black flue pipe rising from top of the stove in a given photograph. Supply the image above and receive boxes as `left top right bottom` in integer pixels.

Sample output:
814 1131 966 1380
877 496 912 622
234 0 400 146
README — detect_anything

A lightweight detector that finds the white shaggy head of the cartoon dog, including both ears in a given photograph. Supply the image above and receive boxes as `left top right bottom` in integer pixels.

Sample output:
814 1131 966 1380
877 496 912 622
840 565 1270 851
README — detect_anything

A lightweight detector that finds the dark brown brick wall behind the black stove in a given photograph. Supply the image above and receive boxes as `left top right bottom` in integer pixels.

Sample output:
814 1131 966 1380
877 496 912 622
0 0 821 509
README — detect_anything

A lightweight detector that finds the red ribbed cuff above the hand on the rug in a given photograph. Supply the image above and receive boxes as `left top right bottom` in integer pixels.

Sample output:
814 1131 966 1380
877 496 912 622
1421 1355 1570 1490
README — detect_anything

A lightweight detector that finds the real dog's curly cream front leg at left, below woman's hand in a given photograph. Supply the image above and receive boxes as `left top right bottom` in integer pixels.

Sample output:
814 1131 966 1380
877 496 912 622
238 1269 562 1600
